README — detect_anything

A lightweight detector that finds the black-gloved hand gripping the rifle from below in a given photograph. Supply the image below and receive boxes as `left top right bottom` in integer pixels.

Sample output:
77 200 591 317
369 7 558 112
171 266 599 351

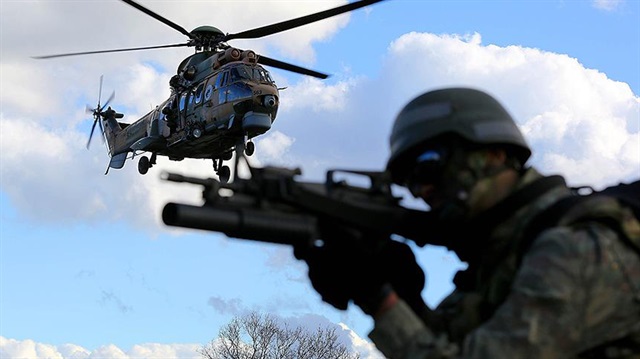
294 227 426 314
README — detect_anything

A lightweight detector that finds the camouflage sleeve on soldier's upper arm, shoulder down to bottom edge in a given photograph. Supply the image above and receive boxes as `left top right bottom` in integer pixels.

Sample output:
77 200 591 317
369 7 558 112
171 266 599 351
463 227 613 358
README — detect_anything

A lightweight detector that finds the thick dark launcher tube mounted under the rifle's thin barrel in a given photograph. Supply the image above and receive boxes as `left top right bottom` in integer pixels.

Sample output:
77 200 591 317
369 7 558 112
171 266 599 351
162 203 318 245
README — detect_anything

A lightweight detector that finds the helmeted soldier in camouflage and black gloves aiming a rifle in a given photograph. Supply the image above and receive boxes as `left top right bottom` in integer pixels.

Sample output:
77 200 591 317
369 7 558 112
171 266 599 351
305 88 640 359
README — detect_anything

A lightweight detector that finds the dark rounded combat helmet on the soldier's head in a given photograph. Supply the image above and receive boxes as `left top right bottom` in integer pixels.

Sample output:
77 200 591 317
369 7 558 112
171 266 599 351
387 88 531 183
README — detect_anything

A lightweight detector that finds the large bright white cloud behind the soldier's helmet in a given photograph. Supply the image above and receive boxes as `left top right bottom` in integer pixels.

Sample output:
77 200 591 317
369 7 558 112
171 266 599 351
292 33 640 186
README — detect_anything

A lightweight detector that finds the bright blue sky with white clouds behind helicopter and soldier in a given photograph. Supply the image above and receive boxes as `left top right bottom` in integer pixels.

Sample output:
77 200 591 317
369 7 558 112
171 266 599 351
0 0 640 359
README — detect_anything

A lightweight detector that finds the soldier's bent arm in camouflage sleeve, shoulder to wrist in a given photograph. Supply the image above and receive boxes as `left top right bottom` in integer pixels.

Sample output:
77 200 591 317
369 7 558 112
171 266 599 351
370 226 637 359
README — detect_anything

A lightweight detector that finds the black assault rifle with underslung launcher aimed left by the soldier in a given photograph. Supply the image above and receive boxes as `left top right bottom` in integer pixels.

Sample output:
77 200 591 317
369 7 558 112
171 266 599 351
162 167 435 248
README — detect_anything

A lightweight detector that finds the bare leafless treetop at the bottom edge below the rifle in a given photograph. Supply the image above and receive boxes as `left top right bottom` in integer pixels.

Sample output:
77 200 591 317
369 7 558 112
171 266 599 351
199 312 360 359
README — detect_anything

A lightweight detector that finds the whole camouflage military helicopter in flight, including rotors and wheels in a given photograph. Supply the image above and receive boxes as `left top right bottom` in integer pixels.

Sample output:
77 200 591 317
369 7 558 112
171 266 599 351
34 0 382 182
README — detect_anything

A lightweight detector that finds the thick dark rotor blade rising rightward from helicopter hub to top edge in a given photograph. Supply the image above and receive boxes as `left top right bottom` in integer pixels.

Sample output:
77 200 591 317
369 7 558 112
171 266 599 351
225 0 383 41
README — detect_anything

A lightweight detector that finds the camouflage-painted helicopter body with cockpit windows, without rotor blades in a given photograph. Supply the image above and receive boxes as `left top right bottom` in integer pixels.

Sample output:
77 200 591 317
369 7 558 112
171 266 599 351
104 48 279 168
